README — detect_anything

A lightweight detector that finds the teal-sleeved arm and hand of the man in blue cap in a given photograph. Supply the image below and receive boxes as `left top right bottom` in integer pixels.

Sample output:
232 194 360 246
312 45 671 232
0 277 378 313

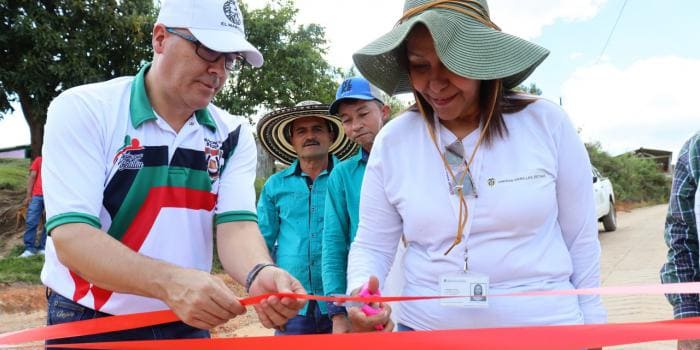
321 170 350 333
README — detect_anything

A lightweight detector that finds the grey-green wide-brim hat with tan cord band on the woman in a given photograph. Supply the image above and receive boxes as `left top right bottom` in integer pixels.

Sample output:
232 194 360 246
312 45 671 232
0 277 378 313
353 0 549 95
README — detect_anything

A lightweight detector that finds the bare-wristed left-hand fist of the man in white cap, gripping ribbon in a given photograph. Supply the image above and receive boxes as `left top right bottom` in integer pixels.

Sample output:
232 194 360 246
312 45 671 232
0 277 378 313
162 269 246 329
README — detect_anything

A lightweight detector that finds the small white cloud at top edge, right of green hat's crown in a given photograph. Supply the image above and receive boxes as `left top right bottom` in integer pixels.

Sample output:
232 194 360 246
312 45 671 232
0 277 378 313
489 0 607 39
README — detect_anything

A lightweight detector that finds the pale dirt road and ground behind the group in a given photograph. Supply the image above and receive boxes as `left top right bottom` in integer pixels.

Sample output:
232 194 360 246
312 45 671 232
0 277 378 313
0 205 675 350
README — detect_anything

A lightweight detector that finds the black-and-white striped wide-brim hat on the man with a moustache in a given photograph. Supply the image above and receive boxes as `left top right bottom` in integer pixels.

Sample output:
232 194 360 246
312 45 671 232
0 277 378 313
257 101 358 165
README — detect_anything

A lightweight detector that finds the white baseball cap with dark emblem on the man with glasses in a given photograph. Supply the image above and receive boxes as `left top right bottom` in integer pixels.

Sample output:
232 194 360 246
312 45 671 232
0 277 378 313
156 0 263 67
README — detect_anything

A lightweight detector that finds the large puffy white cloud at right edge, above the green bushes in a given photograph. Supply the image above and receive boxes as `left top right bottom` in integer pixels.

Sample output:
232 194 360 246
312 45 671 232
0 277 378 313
562 56 700 158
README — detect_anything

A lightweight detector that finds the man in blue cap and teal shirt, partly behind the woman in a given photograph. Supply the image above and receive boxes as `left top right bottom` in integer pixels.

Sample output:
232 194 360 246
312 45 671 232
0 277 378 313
322 77 389 333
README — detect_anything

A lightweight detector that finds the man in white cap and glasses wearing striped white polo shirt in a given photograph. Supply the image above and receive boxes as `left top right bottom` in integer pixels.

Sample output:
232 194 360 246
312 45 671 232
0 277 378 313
41 0 305 343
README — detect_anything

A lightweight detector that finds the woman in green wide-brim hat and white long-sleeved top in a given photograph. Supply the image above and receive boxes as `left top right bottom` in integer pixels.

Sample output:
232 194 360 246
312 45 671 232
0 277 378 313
348 0 606 330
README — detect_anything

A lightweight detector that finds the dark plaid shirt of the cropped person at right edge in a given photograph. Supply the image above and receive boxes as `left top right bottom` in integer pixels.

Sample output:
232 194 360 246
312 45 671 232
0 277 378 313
661 133 700 318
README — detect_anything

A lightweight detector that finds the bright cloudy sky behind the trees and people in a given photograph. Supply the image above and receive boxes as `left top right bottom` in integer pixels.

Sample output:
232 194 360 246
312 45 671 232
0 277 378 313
0 0 700 161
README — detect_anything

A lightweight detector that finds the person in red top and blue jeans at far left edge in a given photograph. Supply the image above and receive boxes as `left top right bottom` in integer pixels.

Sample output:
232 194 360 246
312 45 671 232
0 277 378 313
19 156 46 258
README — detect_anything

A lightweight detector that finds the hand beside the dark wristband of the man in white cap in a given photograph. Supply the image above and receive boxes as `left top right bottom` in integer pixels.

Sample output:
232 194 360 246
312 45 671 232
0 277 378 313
250 266 306 328
